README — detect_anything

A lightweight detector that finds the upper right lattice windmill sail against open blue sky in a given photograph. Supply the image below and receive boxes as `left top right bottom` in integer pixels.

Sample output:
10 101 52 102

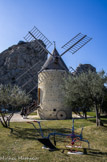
61 33 92 56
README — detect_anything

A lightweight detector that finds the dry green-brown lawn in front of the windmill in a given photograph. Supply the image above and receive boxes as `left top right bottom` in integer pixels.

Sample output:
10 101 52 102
0 118 107 162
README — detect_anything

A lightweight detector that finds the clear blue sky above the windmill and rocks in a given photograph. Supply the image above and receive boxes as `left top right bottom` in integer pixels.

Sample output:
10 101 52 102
0 0 107 72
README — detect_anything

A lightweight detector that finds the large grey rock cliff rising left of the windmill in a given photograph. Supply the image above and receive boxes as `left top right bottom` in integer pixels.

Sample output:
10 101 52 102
0 41 47 98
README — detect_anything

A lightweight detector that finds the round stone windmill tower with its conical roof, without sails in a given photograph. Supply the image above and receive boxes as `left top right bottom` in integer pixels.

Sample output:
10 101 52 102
38 48 72 119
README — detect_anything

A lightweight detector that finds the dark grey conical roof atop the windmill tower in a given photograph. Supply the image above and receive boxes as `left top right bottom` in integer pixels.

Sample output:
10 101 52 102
40 48 69 72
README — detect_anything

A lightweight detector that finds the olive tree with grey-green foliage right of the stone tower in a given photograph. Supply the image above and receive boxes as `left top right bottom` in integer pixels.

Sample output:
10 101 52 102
64 71 107 126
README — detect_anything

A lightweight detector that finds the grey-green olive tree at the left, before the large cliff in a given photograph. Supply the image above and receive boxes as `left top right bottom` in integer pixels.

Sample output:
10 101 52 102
0 84 31 128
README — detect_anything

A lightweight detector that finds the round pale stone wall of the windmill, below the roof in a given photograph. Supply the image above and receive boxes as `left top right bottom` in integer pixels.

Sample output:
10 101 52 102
38 70 72 119
